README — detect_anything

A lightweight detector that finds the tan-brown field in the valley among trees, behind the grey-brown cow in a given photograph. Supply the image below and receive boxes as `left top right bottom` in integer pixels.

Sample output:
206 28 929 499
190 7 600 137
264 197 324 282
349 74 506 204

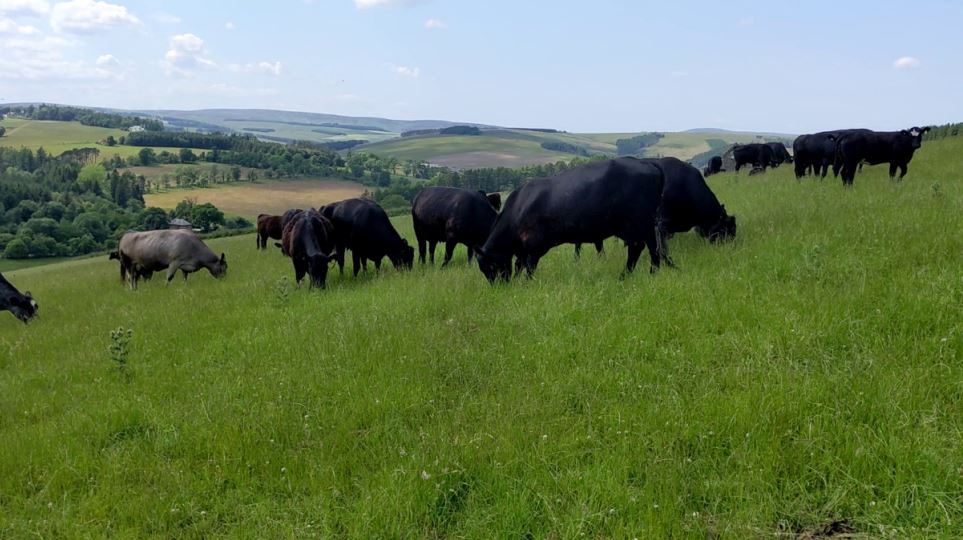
144 179 365 218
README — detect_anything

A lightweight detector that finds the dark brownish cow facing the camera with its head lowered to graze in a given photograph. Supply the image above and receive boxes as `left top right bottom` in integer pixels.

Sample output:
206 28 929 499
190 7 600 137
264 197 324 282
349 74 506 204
281 209 336 289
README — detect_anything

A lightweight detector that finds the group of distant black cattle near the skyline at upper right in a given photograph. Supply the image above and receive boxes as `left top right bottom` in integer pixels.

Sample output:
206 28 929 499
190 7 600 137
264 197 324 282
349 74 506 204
703 127 930 185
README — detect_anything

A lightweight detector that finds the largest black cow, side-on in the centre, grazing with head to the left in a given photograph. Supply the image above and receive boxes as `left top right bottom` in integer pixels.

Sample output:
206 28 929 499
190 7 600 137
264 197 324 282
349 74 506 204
475 157 665 283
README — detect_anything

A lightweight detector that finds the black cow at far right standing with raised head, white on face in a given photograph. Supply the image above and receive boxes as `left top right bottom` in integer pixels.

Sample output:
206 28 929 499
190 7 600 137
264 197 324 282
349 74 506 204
836 127 930 185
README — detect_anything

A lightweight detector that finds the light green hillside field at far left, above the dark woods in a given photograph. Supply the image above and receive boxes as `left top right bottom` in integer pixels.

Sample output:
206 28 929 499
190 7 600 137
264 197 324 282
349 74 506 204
0 118 203 159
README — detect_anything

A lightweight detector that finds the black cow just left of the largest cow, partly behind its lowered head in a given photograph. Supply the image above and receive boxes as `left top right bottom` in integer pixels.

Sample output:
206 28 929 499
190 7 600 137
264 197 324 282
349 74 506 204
411 187 501 267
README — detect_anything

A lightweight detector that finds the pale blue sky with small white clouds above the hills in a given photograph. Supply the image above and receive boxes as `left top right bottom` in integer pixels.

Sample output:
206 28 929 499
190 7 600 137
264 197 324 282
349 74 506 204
0 0 963 133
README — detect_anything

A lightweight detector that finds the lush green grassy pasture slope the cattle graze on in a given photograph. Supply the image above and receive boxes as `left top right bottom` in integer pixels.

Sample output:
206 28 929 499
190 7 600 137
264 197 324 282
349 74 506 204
0 140 963 538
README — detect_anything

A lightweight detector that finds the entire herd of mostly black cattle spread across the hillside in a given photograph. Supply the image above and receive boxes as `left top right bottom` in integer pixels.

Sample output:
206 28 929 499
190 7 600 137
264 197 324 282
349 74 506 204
0 127 929 322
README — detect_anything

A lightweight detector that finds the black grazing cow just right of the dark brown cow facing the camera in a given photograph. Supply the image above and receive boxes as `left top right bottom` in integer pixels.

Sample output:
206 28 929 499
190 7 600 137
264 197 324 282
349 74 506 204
321 199 415 276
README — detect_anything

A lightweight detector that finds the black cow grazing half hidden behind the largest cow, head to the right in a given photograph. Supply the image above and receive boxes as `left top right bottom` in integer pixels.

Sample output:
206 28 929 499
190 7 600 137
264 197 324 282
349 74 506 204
653 157 736 242
